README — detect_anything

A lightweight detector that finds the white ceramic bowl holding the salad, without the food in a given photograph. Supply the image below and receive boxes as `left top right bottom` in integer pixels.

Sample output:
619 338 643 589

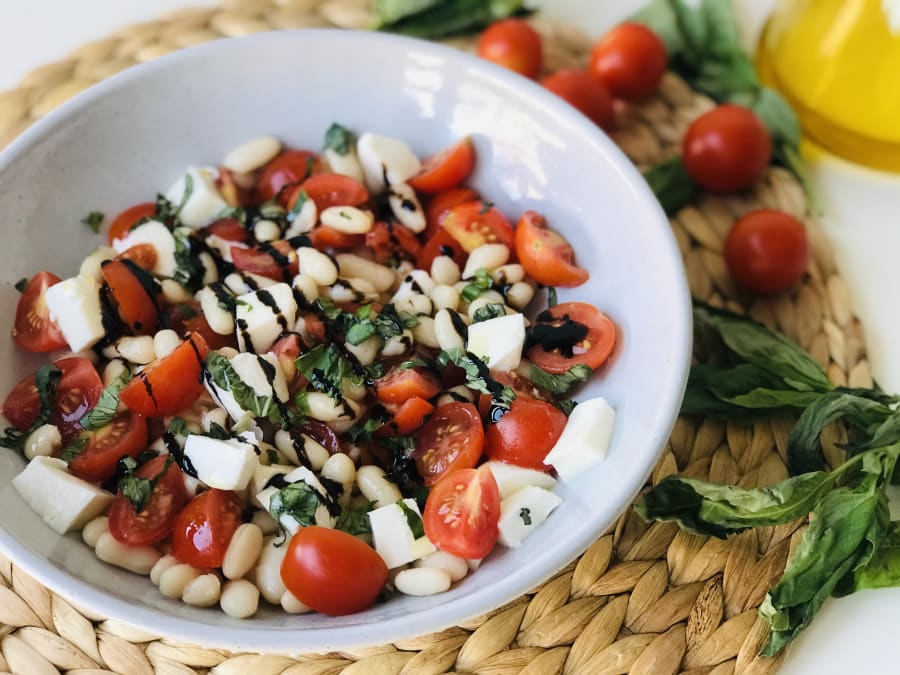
0 31 691 651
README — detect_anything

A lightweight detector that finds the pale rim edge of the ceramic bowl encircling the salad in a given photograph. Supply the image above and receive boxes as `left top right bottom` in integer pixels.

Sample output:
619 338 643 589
0 29 692 653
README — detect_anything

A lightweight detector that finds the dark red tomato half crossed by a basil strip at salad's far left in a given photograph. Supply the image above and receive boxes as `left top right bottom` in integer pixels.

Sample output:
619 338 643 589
3 356 103 441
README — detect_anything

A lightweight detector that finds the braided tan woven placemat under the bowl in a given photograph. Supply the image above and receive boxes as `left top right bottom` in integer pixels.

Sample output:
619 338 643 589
0 0 872 675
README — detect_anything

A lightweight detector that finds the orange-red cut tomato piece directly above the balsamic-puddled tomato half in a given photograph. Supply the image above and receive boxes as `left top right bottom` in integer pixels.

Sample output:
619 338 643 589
516 211 590 287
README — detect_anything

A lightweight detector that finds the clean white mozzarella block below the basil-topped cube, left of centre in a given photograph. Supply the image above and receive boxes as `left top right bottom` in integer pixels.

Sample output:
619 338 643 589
184 434 259 490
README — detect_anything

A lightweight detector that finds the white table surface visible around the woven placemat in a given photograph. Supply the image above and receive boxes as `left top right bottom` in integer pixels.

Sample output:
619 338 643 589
0 0 900 675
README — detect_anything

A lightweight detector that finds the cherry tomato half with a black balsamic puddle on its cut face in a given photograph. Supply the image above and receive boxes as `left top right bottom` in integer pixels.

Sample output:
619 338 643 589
528 302 616 373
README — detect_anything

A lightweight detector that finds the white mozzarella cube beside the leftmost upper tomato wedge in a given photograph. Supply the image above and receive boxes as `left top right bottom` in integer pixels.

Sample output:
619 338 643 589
44 276 106 352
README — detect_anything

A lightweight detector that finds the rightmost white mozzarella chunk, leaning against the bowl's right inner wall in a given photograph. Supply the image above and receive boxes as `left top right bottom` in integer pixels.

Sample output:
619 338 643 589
544 397 616 481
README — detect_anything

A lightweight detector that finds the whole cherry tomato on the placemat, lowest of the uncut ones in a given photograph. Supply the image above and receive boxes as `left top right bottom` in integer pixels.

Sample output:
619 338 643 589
725 209 810 295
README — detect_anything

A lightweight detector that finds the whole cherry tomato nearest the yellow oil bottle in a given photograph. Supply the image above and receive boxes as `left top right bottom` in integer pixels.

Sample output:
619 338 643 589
681 103 772 192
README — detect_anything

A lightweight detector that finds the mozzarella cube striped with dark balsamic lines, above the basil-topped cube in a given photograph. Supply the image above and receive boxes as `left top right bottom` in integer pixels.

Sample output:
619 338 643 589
235 283 297 353
